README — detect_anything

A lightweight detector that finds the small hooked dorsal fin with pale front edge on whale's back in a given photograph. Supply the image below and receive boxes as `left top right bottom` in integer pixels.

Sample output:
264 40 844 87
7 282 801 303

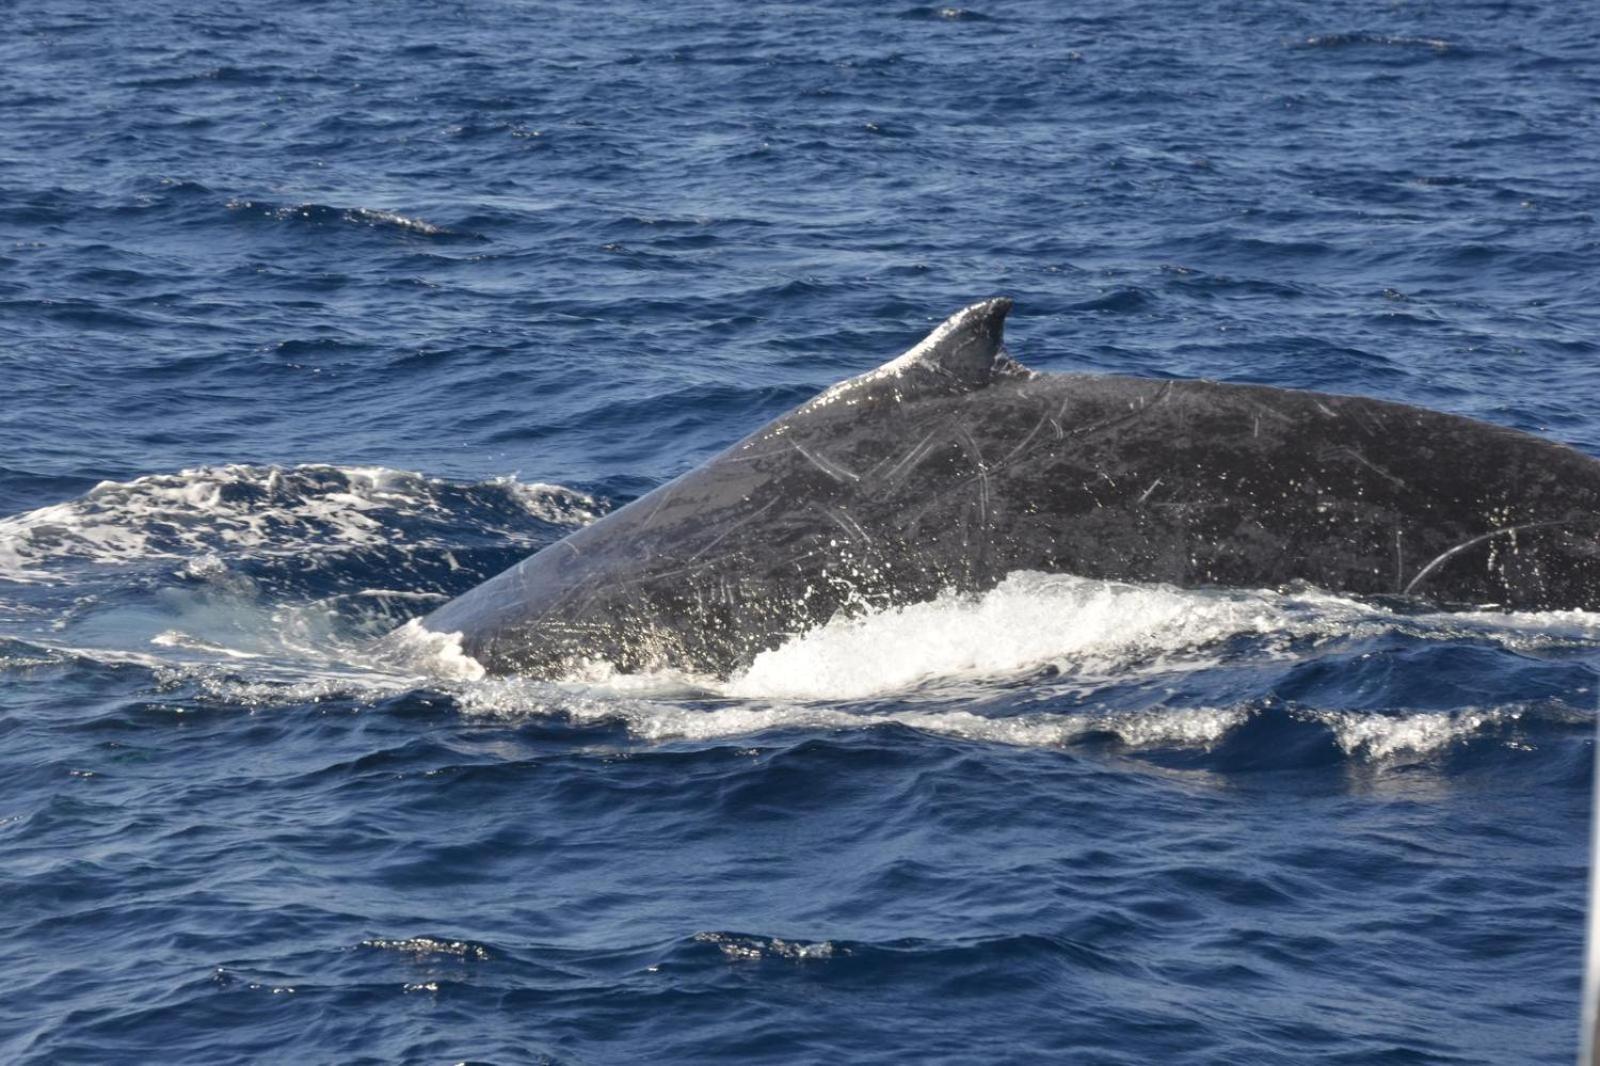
802 296 1034 410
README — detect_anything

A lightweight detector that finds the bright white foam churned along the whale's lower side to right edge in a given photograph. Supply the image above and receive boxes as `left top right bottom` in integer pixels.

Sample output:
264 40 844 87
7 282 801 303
422 571 1600 762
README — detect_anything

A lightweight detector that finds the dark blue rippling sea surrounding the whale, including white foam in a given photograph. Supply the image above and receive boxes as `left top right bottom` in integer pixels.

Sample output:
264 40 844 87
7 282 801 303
0 0 1600 1064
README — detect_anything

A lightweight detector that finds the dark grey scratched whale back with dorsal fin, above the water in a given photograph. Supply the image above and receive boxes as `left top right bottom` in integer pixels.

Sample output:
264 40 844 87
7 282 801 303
422 298 1600 677
